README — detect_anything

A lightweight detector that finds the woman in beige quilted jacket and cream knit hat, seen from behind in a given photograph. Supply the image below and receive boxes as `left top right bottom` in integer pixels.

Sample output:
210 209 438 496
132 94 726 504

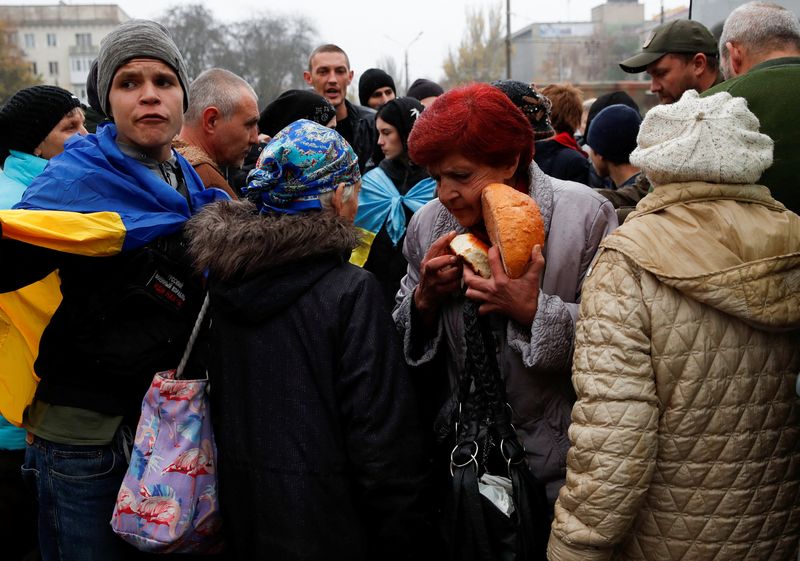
548 90 800 561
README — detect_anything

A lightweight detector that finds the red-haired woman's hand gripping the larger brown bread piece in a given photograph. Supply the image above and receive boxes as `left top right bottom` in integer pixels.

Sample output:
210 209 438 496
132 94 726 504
464 245 544 325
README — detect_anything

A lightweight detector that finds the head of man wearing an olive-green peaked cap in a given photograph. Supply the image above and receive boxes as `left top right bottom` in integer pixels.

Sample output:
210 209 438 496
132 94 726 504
619 19 722 104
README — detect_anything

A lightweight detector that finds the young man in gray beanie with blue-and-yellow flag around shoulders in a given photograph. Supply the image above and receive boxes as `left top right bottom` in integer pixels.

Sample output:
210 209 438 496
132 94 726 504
0 20 227 561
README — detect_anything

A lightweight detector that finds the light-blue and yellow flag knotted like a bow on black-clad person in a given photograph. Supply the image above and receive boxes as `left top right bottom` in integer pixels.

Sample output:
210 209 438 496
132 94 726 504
350 168 436 267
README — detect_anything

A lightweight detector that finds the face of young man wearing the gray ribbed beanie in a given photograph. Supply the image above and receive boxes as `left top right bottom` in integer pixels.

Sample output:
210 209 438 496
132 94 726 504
108 58 183 162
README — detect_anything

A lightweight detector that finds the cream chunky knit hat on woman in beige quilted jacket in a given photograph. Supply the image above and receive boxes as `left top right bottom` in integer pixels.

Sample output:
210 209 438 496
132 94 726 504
630 90 772 185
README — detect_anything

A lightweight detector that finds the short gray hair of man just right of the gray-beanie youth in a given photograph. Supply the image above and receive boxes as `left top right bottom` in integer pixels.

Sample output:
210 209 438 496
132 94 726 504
184 68 258 124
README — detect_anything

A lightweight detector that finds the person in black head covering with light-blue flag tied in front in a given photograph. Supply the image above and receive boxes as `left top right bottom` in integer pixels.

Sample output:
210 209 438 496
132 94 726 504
351 97 436 310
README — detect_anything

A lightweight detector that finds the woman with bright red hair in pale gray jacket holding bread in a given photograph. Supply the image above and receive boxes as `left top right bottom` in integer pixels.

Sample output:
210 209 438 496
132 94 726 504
394 84 617 505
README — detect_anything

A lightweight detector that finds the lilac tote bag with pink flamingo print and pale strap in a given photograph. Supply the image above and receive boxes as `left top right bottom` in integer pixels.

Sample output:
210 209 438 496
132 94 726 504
111 296 223 553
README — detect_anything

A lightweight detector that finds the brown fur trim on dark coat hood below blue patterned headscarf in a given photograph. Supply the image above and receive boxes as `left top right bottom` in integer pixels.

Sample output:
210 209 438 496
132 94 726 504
186 200 358 281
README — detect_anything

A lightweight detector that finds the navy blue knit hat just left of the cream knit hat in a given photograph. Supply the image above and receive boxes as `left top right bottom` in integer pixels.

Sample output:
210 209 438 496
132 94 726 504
586 104 642 164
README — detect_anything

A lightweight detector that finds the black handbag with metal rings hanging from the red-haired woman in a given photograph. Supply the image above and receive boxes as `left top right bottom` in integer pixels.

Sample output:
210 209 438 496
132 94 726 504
445 300 551 561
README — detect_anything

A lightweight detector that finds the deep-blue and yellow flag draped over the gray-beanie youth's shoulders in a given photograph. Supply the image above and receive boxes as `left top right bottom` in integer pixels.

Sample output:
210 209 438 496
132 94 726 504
0 123 228 425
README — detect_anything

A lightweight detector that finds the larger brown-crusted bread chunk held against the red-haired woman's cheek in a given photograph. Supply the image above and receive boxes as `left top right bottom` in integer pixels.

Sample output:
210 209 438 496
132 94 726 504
481 183 544 279
